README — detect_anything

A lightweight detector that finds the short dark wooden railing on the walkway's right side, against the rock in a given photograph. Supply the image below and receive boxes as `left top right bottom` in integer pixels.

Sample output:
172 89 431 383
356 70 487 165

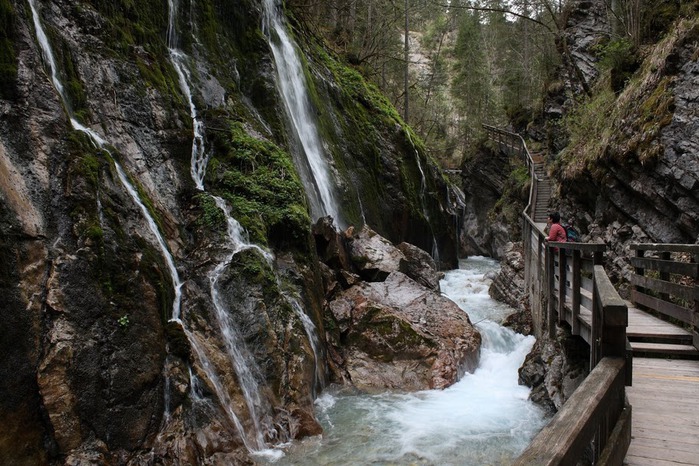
631 243 699 349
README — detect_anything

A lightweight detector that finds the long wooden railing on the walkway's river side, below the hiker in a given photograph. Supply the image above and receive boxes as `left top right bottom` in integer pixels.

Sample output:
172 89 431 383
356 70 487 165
484 125 631 466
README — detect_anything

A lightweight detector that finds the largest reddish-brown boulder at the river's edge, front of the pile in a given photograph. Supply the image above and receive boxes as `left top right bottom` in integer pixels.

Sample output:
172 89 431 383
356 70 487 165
329 271 481 390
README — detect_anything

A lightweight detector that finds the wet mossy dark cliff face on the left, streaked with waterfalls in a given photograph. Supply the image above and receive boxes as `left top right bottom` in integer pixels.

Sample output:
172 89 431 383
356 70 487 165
0 0 462 465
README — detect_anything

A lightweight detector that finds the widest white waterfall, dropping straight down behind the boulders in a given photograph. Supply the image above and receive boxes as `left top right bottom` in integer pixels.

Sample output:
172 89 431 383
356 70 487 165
263 0 345 228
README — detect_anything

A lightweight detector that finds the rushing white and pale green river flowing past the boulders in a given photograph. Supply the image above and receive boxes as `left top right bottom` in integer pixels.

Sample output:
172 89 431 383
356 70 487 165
266 257 546 466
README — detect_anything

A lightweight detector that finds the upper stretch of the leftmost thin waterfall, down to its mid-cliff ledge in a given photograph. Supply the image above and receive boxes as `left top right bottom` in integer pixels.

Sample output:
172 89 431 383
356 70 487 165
29 0 182 320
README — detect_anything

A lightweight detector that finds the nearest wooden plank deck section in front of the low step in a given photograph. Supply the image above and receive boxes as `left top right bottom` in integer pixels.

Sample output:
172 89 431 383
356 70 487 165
624 358 699 466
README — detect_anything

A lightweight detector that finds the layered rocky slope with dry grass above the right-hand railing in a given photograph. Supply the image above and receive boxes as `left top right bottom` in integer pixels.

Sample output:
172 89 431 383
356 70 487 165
553 5 699 282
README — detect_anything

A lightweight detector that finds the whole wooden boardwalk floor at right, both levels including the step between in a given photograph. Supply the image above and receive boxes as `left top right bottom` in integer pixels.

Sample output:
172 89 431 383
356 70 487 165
624 307 699 466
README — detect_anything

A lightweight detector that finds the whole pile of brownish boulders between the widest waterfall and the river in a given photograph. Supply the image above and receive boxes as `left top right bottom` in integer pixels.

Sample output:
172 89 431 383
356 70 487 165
316 225 481 390
